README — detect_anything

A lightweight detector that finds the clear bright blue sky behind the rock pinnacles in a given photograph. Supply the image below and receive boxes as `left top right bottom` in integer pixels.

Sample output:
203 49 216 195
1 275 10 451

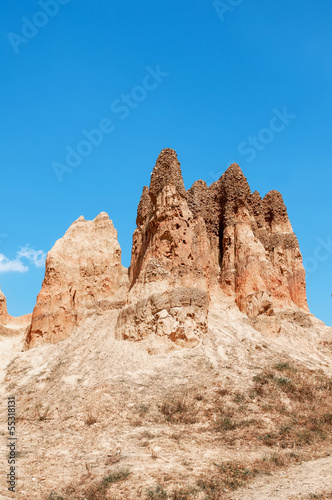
0 0 332 324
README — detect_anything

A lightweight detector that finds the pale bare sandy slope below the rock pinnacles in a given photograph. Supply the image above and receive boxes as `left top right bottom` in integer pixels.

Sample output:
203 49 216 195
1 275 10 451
0 300 332 500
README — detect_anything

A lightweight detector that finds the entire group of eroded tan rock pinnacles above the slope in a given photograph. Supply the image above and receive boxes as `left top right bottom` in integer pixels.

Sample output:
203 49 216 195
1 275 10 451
24 149 308 352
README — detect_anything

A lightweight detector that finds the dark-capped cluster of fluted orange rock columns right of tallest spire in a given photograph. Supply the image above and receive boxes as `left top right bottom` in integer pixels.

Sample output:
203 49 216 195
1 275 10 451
188 164 308 335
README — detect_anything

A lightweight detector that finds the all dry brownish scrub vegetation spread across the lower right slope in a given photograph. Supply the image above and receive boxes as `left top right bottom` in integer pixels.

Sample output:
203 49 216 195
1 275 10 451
44 360 332 500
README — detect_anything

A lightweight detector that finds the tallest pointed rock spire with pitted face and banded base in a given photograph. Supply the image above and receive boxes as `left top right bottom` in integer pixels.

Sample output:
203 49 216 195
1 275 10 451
116 149 210 349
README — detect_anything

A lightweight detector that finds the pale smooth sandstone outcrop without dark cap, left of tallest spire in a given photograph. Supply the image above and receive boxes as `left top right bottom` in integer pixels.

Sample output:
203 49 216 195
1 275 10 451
26 212 128 347
